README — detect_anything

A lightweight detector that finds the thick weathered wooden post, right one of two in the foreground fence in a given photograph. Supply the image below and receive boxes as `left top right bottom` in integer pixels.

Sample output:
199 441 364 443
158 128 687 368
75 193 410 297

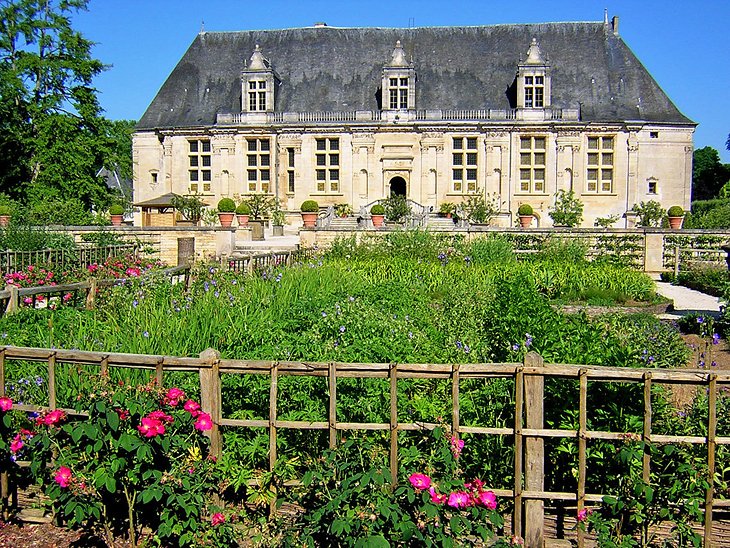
523 352 545 548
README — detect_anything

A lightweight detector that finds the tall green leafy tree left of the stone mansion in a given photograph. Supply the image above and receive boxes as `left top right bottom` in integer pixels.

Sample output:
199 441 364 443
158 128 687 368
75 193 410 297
0 0 111 207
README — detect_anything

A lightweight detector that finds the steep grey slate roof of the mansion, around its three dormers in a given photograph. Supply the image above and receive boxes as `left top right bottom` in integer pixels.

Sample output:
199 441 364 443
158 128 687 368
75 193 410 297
138 22 692 129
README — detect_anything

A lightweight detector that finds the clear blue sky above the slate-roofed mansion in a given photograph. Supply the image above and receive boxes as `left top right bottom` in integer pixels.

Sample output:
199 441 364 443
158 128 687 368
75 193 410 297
74 0 730 162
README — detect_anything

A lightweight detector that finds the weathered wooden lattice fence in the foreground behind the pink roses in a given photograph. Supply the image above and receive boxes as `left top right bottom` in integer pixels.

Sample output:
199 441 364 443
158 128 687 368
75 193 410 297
0 346 730 547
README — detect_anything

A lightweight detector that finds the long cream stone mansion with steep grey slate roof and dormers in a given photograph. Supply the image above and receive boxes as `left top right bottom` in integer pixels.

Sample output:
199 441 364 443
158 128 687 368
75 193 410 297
134 19 694 227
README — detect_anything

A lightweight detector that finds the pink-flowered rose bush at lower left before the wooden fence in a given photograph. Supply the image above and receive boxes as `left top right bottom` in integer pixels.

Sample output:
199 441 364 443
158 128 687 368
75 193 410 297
0 375 234 546
